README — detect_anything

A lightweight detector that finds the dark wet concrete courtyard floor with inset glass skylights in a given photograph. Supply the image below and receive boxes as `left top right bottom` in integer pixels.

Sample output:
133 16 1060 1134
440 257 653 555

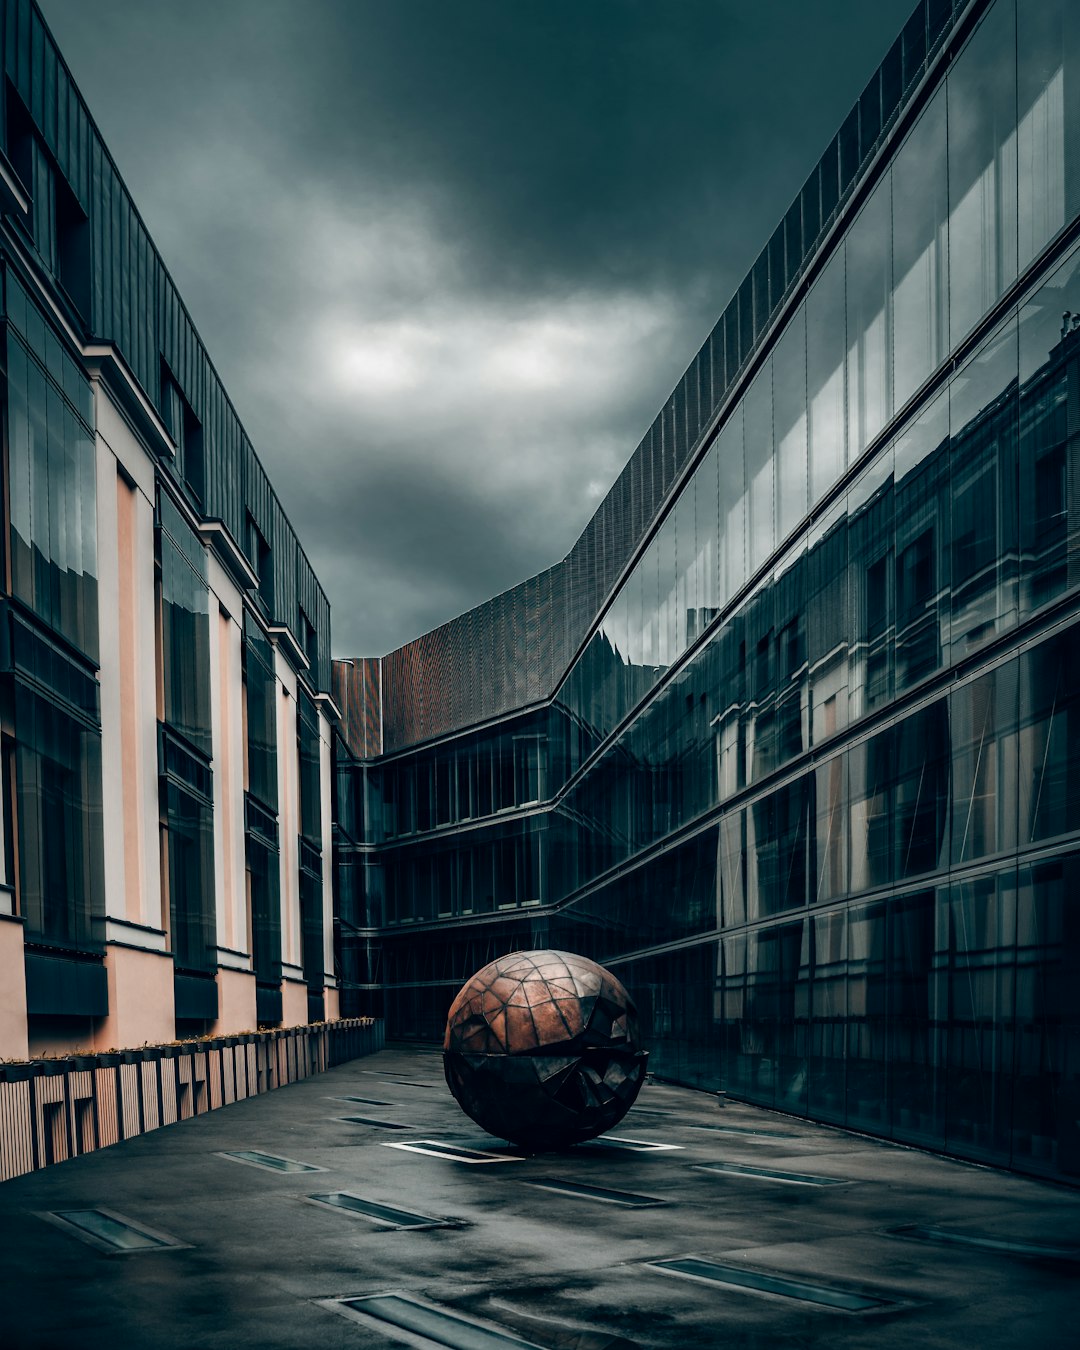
0 1048 1080 1350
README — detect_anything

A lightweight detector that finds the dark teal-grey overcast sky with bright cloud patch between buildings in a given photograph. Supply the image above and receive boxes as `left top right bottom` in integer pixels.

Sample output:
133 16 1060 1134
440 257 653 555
41 0 914 655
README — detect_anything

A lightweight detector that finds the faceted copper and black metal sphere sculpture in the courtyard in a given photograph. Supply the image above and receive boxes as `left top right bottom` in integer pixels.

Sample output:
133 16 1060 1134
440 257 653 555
443 952 648 1149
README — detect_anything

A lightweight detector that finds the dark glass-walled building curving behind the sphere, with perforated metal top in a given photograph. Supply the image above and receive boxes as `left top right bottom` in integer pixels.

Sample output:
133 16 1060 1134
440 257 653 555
335 0 1080 1176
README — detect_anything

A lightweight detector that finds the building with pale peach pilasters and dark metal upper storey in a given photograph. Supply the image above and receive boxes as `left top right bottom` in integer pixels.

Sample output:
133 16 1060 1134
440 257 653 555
0 0 338 1058
